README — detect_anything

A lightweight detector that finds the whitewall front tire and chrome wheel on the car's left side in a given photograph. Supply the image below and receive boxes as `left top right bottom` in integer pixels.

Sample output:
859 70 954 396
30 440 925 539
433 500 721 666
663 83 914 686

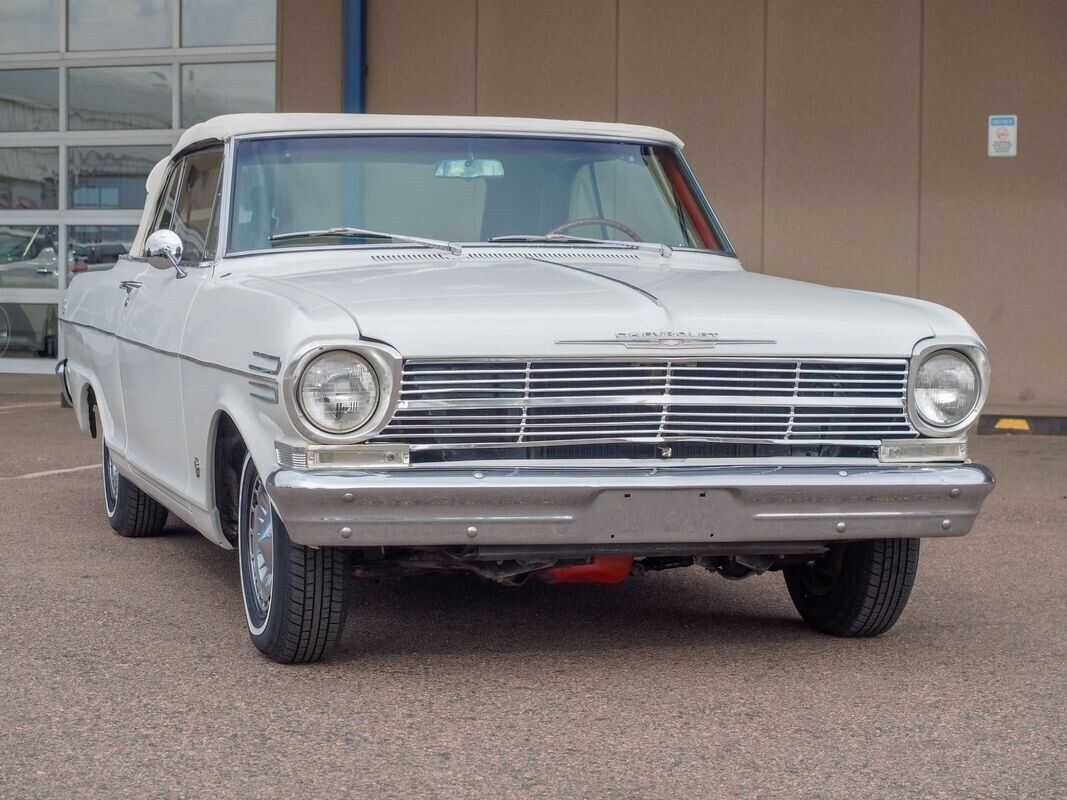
237 457 349 663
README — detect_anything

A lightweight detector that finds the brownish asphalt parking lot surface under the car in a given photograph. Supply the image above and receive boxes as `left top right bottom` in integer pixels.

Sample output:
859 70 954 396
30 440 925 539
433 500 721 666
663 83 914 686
0 387 1067 798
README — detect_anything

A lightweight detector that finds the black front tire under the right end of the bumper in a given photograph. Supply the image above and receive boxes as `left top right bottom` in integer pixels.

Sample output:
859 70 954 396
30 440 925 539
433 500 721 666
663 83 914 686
783 539 919 637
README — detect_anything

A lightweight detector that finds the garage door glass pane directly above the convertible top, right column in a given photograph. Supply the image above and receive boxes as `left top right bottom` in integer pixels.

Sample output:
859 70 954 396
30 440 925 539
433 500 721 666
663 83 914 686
181 61 274 128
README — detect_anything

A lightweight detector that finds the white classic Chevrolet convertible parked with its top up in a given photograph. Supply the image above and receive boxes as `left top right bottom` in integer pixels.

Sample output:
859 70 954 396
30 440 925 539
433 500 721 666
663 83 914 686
59 114 993 661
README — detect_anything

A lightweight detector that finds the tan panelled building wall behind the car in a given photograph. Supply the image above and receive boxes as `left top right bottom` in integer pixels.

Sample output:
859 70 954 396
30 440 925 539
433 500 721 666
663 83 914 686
278 0 1067 414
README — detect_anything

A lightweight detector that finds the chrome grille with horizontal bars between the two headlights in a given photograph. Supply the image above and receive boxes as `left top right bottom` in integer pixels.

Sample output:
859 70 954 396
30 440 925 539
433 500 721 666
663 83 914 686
378 358 917 450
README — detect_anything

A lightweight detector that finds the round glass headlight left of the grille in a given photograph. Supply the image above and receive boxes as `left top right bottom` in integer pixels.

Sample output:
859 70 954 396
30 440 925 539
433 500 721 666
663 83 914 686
299 350 378 433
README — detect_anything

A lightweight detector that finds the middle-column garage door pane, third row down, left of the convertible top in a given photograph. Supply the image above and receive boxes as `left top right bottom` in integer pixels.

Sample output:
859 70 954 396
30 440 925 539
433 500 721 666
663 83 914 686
67 145 170 209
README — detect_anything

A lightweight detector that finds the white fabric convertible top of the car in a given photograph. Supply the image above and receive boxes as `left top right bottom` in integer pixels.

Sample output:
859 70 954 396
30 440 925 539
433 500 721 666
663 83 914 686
134 114 682 247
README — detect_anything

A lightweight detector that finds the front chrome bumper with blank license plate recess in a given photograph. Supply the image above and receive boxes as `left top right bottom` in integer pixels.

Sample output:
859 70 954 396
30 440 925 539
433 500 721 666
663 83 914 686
268 464 994 547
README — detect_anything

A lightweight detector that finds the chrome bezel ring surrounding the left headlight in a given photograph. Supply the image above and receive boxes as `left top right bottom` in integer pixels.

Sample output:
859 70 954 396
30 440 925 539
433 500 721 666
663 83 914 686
282 341 402 445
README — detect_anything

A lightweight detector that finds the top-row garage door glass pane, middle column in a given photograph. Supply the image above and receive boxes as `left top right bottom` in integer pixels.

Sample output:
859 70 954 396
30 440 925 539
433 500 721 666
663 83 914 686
67 0 174 50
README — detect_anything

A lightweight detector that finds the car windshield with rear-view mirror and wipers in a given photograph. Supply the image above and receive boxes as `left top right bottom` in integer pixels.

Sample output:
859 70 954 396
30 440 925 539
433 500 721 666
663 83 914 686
227 135 724 253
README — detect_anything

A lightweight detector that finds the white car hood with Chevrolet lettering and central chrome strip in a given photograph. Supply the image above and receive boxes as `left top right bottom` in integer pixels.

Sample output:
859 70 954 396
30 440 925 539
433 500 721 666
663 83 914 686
245 250 973 357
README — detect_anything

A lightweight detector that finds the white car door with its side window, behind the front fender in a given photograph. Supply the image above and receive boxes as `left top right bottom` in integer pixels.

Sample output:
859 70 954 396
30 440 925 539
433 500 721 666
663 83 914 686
118 148 222 502
